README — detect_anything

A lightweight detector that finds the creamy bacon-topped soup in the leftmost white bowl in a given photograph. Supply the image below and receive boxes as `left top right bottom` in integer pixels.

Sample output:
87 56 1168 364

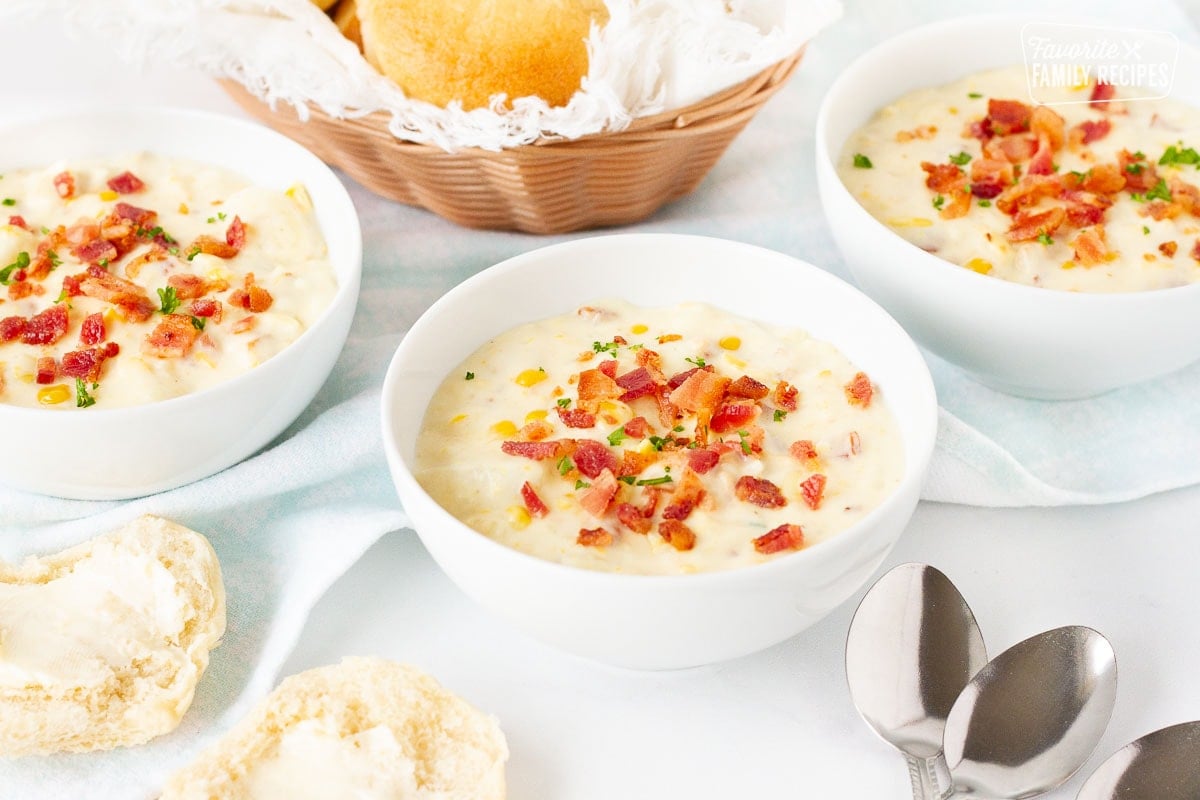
0 154 337 409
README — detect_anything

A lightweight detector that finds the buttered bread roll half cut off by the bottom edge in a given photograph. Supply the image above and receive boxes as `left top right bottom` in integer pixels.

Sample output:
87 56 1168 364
161 658 509 800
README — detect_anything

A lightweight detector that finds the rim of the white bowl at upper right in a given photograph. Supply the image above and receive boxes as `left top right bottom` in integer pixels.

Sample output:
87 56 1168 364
815 12 1200 306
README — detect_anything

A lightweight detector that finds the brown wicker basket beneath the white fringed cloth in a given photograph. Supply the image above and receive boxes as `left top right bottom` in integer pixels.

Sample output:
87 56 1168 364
223 50 803 234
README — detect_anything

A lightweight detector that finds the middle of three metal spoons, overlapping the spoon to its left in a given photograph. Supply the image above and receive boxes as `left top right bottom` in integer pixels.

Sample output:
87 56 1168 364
944 626 1117 800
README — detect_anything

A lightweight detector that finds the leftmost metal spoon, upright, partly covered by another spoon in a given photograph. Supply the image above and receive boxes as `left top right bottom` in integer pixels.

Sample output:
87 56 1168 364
846 564 988 800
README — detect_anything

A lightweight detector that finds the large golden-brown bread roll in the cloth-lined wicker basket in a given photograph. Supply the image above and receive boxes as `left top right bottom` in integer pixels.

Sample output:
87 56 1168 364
356 0 608 109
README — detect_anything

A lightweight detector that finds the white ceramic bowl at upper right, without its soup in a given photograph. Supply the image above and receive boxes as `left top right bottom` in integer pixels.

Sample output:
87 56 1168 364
816 16 1200 399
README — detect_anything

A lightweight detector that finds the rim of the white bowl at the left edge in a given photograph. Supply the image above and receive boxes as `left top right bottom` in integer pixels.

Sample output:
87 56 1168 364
0 106 362 425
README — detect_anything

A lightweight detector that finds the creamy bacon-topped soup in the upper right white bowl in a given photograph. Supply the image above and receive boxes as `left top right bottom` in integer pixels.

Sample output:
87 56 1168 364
839 66 1200 291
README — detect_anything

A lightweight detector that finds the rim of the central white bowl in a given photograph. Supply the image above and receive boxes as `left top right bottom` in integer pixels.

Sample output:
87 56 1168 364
380 233 938 587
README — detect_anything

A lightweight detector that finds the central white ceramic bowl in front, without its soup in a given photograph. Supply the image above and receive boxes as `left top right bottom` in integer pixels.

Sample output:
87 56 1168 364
383 234 937 669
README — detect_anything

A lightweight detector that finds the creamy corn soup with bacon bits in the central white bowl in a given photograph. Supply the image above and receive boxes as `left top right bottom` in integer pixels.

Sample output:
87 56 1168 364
415 300 904 575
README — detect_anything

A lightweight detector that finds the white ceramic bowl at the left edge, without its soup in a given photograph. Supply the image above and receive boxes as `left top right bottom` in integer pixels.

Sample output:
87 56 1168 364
0 109 362 500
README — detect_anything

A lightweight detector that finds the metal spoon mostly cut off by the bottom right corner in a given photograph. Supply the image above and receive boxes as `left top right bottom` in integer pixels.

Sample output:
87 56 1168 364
1078 722 1200 800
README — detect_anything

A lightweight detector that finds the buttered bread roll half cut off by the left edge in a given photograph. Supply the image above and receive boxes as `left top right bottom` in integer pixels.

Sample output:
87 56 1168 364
0 516 226 756
